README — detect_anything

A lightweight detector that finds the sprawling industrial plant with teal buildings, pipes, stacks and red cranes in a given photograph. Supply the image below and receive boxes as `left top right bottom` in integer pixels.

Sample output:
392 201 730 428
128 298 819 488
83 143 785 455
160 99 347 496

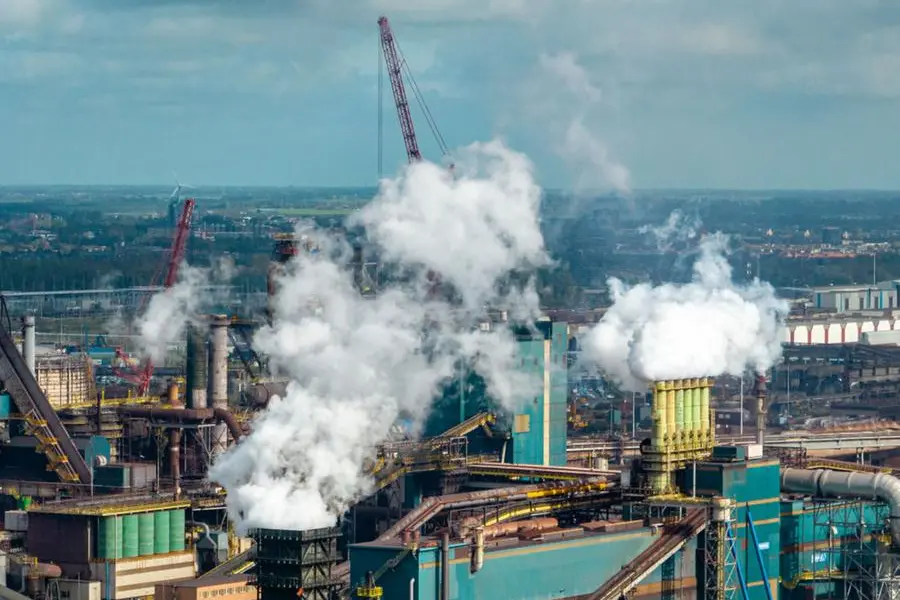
0 10 900 600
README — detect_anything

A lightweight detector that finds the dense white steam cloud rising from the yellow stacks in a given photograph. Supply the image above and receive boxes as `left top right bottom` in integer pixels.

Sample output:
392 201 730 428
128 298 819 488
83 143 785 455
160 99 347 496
583 234 788 391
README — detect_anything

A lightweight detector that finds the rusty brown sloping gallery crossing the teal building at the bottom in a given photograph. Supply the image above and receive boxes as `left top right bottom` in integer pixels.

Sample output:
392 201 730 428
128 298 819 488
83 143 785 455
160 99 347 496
584 509 707 600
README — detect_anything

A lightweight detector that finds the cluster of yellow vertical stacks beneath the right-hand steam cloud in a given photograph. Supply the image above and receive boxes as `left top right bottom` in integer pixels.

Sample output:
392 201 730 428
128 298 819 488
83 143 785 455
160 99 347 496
641 377 715 494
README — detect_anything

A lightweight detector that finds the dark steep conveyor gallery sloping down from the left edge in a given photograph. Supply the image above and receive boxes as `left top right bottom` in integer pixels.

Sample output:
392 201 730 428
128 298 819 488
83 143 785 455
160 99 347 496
0 325 91 483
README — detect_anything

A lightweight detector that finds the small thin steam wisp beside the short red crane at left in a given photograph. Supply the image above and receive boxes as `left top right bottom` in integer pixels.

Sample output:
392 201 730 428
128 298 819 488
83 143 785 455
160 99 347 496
136 260 234 363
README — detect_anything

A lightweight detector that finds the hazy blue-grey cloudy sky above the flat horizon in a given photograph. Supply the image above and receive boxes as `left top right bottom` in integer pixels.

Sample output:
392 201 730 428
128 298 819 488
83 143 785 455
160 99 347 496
0 0 900 191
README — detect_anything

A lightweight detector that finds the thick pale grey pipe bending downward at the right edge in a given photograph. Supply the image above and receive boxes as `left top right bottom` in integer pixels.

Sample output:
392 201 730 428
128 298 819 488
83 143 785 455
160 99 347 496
781 469 900 546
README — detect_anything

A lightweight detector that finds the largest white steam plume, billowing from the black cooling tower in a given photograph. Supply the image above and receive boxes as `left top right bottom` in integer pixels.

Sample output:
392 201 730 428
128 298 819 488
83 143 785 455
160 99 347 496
210 142 547 530
